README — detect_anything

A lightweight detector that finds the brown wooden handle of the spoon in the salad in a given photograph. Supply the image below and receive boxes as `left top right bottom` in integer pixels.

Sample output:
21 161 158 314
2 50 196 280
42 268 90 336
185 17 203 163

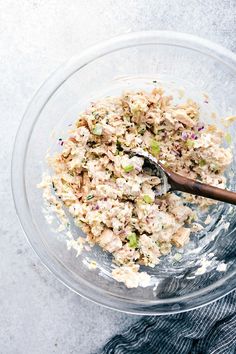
168 172 236 205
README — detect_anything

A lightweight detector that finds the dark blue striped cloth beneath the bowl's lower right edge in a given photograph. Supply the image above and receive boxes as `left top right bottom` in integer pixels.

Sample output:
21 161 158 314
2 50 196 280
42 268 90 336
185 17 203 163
101 291 236 354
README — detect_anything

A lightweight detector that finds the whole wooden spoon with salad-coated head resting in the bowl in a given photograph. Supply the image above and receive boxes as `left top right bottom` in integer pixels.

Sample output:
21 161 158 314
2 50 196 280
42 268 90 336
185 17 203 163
129 150 236 205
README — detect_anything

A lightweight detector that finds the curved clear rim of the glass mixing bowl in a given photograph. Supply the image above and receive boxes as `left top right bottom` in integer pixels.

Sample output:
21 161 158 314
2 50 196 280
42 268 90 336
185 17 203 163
11 31 236 315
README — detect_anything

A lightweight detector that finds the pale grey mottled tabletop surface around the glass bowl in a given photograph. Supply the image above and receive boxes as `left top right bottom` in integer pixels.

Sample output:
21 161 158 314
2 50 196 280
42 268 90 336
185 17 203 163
0 0 236 354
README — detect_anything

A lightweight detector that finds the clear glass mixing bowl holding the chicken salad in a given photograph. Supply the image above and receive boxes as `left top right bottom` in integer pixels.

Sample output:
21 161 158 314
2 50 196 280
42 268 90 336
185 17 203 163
12 31 236 315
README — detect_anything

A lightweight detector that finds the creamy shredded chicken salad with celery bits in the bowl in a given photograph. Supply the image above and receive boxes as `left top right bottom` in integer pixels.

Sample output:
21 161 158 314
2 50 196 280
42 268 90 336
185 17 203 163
40 88 232 287
